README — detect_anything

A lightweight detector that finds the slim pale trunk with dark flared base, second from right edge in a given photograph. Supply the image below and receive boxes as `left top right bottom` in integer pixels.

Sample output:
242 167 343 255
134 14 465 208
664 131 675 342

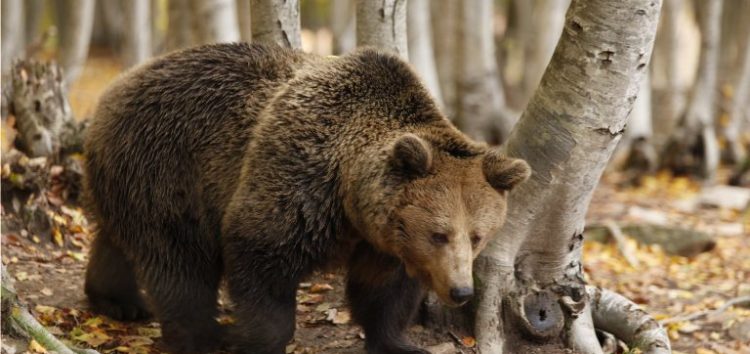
663 0 723 181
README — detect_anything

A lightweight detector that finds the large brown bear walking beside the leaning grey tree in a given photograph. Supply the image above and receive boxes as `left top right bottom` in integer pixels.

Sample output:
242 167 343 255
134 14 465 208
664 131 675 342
85 44 530 354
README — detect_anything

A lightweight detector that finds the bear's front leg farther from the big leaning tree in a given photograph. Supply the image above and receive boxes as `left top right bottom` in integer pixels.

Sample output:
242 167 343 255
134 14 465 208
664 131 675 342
225 240 299 354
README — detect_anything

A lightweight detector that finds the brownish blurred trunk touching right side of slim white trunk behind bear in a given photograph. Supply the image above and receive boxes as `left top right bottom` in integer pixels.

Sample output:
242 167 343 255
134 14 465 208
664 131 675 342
430 0 460 120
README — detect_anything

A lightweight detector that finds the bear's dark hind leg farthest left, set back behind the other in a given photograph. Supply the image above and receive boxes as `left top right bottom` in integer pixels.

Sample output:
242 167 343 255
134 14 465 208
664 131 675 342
85 230 151 321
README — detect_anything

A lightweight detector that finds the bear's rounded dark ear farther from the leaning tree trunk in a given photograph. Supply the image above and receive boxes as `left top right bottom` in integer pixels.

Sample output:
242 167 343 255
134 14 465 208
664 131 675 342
390 134 432 178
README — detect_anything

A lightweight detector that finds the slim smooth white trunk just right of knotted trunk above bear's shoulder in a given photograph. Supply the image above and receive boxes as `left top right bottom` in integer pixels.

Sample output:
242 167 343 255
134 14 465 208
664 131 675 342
406 0 443 107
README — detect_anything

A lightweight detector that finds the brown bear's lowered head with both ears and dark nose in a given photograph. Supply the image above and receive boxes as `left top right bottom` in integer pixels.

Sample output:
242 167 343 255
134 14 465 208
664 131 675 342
362 133 531 306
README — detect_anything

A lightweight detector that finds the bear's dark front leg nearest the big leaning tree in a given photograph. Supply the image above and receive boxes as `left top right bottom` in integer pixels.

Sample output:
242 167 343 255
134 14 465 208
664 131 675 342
346 243 428 354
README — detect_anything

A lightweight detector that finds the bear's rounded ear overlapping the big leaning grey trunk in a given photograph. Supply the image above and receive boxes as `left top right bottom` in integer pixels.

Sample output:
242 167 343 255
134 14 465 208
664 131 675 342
482 149 531 191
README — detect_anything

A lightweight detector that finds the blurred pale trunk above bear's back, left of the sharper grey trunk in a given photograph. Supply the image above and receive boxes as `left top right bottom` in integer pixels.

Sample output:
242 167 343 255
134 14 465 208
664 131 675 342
191 0 240 44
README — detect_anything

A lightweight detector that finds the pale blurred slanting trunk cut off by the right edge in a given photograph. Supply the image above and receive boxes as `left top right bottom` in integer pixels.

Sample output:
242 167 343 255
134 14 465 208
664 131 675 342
724 26 750 164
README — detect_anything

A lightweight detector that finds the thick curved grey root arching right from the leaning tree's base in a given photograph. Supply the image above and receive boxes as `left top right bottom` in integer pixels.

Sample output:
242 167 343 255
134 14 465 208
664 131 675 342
586 286 671 354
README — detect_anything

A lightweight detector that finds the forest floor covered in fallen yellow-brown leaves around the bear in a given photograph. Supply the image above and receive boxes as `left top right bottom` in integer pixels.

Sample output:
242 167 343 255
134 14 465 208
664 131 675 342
2 53 750 354
